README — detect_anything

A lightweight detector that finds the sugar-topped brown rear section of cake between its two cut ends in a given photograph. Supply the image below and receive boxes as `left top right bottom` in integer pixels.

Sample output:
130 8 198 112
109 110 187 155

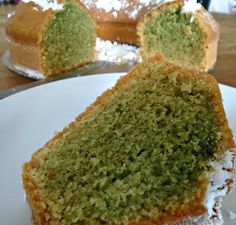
81 0 161 45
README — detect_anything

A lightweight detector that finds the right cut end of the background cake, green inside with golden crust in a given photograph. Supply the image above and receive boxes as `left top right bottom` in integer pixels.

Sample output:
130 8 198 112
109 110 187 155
137 0 219 71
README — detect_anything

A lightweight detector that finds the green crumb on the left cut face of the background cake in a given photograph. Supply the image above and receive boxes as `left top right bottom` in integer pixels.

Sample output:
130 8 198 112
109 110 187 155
41 1 95 75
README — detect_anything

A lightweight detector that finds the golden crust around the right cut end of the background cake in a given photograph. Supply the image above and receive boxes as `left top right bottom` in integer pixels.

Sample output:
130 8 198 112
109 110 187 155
137 0 220 71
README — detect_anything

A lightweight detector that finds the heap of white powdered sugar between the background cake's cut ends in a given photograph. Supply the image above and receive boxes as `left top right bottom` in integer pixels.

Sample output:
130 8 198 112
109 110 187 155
96 38 141 64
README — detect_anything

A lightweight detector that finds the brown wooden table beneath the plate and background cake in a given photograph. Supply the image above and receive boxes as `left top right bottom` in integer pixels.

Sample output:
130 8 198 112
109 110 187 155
0 5 236 90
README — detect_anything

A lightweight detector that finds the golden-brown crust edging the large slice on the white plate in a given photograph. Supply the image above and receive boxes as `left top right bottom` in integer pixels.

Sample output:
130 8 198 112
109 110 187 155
22 56 235 225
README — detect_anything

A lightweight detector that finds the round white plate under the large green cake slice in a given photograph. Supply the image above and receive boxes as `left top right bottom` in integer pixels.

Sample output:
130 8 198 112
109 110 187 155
0 73 236 225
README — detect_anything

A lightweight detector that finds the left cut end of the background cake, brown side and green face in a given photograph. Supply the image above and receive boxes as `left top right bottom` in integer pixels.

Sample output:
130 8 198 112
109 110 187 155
6 0 96 77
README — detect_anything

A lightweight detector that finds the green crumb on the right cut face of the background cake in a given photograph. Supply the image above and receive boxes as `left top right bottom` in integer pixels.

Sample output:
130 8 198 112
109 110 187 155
142 6 206 69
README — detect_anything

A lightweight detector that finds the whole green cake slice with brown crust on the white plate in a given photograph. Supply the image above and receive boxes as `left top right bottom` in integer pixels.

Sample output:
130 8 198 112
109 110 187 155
23 57 235 225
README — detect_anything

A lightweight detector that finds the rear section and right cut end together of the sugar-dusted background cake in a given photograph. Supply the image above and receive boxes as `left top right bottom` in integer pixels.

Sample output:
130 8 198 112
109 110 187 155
82 0 220 71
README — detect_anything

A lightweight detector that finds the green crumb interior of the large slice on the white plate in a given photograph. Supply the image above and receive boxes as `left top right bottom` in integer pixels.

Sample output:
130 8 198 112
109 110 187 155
34 64 221 225
